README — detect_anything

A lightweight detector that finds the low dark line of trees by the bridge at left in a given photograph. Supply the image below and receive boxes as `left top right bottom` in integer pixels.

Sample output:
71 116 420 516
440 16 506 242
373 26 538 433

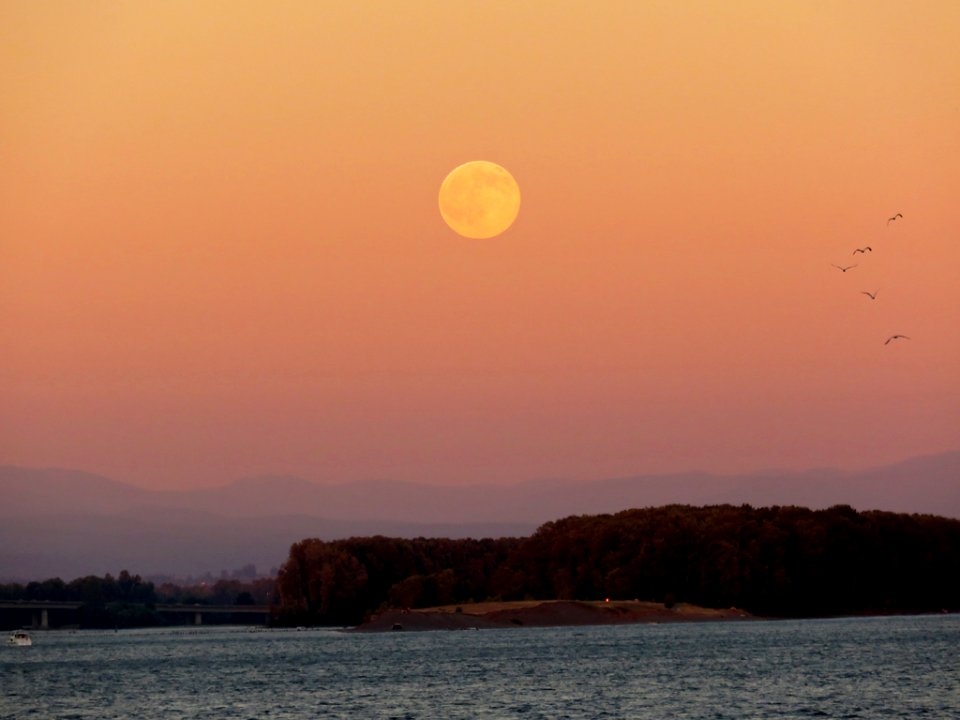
0 570 276 627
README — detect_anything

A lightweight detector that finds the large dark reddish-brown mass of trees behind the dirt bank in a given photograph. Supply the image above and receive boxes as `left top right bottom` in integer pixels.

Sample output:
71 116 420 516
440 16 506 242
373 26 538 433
277 505 960 625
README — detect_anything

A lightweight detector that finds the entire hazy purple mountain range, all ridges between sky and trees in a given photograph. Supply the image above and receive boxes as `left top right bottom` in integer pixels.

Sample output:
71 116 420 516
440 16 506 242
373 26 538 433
0 451 960 581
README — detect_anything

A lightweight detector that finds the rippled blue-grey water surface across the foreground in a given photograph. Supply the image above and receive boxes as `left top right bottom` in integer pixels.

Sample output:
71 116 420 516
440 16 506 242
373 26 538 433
0 615 960 720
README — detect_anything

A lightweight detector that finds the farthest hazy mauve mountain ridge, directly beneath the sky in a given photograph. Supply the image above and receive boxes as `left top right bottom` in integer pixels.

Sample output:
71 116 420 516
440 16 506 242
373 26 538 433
0 452 960 524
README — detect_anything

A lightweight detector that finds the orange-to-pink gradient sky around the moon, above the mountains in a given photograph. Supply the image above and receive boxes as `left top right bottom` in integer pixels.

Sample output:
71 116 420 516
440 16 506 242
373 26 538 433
0 0 960 488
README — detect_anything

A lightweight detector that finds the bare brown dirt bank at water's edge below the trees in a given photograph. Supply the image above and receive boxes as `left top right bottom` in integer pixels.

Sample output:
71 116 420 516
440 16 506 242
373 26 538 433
353 600 753 632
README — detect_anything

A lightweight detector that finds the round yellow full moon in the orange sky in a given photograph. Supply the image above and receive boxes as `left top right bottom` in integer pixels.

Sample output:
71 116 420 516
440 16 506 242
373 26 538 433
440 160 520 239
